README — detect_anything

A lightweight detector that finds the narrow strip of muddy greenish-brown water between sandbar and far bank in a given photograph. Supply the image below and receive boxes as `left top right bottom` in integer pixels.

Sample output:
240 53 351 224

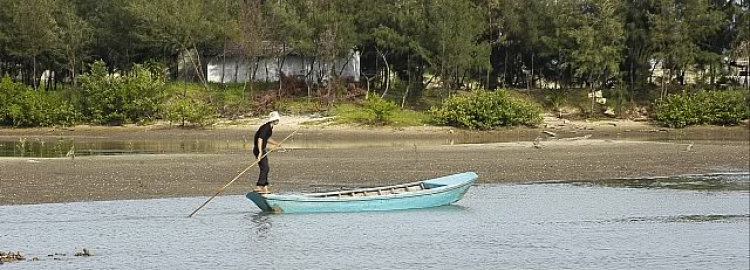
0 126 748 158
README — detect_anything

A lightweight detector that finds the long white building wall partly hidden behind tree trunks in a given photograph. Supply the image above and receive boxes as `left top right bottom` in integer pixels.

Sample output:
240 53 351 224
206 51 360 83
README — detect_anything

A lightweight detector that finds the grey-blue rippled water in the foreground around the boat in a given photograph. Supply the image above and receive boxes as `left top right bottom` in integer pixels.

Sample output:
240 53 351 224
0 174 750 269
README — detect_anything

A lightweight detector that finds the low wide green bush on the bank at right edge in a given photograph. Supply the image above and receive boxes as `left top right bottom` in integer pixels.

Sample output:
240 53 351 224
655 90 750 128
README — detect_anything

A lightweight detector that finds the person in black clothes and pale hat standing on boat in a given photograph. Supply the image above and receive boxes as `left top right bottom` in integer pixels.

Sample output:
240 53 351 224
253 111 281 193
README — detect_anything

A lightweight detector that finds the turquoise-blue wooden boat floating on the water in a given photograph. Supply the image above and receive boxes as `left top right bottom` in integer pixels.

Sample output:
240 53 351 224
246 172 478 213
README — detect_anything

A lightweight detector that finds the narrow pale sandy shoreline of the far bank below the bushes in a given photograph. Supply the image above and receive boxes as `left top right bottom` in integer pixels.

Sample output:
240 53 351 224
0 116 750 141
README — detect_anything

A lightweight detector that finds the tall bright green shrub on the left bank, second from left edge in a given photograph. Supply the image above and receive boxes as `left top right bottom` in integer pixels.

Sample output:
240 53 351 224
79 61 164 125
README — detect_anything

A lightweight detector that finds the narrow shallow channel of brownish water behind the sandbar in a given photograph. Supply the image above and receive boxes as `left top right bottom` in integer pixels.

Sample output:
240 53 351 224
0 127 747 158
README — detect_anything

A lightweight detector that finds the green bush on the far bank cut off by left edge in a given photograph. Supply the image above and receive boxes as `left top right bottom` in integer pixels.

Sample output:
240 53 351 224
0 76 76 127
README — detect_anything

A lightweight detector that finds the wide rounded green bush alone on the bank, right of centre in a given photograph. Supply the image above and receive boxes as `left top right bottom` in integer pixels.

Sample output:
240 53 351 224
430 90 542 129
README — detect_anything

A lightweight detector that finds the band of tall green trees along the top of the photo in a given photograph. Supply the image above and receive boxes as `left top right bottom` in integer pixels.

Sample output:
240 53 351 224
0 0 750 99
